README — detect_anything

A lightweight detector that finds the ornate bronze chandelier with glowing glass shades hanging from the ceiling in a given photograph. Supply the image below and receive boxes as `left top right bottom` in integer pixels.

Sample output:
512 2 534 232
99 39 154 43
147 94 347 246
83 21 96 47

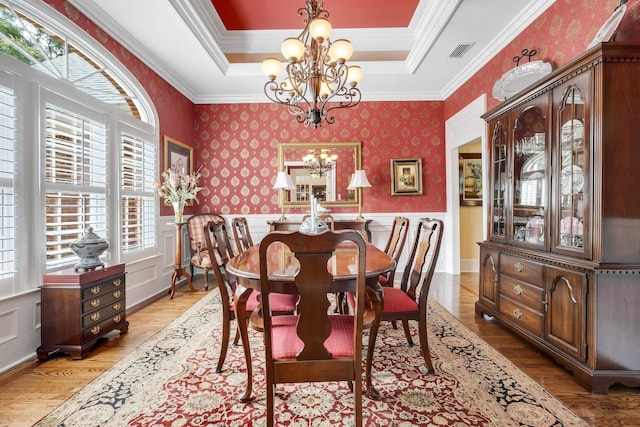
262 0 362 128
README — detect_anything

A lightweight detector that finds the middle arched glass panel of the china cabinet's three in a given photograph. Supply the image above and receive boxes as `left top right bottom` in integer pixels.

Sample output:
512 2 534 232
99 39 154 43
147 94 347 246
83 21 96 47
510 106 548 246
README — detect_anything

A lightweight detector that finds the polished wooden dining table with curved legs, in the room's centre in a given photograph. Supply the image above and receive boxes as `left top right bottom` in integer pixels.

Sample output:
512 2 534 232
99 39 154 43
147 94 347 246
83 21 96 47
226 242 395 402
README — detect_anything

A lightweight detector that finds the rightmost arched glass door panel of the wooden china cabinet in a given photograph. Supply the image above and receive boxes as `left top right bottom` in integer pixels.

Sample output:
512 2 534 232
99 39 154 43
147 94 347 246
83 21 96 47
554 85 589 253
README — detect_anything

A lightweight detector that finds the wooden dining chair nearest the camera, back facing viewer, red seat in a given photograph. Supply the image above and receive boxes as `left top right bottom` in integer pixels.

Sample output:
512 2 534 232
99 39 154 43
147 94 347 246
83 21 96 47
260 230 366 427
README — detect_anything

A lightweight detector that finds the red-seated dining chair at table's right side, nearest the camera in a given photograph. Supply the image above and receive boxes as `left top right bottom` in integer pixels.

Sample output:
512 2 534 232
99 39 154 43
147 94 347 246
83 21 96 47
347 218 443 374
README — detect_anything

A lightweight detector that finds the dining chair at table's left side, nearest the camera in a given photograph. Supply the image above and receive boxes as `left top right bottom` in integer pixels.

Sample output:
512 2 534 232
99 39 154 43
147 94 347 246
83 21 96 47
203 221 297 384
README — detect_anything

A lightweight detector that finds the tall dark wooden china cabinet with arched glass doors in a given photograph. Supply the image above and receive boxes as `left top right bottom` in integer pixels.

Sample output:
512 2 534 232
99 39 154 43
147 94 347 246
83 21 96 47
476 43 640 393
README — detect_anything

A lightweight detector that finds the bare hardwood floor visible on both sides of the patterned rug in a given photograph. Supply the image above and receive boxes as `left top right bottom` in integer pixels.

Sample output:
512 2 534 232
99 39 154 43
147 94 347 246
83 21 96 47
0 274 640 427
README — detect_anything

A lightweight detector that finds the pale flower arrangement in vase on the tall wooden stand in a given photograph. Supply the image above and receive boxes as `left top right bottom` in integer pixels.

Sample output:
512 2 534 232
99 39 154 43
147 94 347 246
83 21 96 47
156 169 203 222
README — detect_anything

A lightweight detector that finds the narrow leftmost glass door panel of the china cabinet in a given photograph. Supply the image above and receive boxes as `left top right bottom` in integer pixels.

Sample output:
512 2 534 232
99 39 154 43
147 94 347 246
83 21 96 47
489 121 507 239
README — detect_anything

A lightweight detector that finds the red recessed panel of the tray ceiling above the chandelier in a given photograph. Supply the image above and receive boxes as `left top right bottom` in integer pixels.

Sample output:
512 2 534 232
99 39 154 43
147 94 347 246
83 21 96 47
211 0 419 31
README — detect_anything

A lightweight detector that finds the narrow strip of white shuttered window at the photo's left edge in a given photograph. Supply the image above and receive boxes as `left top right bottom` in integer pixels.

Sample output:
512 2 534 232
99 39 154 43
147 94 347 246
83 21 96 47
0 81 16 296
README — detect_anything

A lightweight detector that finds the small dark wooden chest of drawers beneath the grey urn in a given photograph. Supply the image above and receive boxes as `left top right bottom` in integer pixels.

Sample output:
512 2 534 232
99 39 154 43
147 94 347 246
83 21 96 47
37 264 129 360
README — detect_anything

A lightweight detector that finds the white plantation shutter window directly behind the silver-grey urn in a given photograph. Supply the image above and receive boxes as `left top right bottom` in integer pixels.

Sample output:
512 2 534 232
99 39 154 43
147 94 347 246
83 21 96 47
45 104 107 268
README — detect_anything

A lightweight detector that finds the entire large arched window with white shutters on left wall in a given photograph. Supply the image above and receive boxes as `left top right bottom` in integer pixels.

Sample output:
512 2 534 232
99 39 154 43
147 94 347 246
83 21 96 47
0 0 158 298
